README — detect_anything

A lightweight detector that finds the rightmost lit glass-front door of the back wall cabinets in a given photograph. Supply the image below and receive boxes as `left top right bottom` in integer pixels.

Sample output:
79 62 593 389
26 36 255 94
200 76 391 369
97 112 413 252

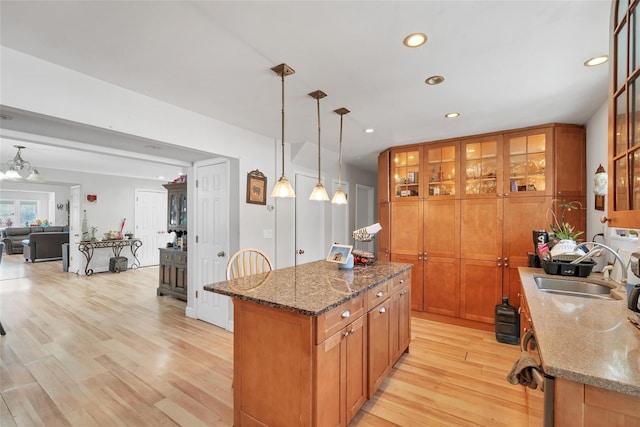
503 128 552 197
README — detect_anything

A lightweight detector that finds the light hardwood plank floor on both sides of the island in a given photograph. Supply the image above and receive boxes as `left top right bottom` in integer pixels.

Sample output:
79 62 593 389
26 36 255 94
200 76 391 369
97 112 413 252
0 255 542 427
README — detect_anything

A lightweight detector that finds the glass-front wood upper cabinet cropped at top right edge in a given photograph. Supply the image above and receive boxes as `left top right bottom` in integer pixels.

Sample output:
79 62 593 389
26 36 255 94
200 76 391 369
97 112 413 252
608 1 640 227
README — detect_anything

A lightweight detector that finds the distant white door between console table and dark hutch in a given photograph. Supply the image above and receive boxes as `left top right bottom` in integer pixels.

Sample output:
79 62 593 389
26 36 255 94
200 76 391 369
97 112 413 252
134 189 168 267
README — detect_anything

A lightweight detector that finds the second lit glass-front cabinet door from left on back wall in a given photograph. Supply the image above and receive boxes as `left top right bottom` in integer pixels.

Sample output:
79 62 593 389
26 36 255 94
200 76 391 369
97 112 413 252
424 142 459 198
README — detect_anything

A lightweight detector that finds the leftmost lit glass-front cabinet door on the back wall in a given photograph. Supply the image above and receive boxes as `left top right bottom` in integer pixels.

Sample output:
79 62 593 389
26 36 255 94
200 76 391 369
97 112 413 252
391 147 423 201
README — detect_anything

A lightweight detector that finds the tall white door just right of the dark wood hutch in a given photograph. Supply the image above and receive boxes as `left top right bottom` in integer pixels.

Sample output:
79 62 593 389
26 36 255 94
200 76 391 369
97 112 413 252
199 161 233 330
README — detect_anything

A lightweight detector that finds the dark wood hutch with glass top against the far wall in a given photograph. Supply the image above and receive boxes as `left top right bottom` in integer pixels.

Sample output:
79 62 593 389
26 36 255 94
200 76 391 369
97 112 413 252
156 182 187 301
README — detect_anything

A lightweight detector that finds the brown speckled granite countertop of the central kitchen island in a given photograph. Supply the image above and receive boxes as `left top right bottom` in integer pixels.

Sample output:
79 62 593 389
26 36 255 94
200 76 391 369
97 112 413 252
204 260 412 316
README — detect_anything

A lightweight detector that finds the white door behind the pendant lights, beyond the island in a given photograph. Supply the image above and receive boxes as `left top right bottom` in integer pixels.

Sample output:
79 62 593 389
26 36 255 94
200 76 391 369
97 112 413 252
295 174 329 265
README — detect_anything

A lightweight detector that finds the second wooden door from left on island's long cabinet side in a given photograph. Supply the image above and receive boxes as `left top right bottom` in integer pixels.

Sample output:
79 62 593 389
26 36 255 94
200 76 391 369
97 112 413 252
344 316 368 426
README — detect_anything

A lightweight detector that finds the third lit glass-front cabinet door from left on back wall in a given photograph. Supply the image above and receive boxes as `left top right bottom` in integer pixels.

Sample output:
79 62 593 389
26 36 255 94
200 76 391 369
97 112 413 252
460 135 502 198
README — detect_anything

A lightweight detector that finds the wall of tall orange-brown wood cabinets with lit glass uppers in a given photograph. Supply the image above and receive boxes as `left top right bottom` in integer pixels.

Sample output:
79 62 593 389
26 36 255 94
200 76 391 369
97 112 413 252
378 124 586 324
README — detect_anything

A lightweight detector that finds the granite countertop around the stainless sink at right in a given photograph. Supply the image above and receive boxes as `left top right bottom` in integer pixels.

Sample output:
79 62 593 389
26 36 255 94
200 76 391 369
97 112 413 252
519 267 640 397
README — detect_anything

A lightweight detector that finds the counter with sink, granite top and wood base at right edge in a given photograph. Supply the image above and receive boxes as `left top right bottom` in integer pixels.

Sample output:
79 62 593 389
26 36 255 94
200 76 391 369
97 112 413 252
519 267 640 425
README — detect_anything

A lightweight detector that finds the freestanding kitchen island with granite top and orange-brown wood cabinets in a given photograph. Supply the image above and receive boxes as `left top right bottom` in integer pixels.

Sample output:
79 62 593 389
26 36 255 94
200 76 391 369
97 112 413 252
204 261 411 427
